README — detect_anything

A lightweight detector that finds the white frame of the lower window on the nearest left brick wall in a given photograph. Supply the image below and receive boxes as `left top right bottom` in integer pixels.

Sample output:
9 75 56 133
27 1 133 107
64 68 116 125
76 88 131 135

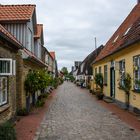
0 77 8 106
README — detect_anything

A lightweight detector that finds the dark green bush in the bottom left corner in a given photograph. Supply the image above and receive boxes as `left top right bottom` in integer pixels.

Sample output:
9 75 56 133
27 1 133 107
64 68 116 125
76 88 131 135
0 122 16 140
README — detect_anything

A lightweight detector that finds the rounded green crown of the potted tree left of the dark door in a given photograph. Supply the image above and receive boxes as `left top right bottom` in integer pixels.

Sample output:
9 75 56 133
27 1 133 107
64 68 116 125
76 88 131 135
94 73 104 92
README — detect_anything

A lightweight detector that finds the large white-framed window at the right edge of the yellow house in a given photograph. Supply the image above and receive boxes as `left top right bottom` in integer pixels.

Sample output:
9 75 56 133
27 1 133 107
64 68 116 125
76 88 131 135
134 56 140 90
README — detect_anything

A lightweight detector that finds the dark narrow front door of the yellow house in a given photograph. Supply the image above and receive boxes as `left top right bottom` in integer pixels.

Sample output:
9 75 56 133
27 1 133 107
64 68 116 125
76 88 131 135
110 68 115 98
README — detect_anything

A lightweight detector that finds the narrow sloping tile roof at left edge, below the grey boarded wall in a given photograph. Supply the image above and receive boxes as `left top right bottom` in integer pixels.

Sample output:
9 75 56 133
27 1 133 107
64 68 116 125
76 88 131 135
0 24 22 47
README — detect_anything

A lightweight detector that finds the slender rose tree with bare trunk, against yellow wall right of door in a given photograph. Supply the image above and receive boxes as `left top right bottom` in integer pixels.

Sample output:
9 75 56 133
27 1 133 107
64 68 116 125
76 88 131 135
121 73 132 109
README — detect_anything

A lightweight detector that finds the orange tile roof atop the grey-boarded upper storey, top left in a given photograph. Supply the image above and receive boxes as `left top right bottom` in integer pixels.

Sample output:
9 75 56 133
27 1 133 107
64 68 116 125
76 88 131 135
0 5 36 22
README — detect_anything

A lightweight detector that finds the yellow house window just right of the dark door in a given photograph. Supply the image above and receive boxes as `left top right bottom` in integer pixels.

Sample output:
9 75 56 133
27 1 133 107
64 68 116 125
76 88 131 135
119 60 125 87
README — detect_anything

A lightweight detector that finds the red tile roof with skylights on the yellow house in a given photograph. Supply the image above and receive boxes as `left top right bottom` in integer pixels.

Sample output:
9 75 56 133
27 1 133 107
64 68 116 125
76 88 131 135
95 4 140 62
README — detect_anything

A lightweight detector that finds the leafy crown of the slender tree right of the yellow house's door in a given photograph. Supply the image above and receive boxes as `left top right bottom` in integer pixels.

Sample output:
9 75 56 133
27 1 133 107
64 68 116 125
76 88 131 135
122 73 132 94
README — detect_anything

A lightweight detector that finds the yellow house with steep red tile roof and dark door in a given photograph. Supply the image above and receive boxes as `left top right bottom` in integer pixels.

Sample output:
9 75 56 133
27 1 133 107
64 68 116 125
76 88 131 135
93 2 140 111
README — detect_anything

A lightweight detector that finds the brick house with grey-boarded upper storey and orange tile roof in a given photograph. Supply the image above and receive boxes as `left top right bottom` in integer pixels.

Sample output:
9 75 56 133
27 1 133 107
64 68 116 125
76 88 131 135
0 5 47 109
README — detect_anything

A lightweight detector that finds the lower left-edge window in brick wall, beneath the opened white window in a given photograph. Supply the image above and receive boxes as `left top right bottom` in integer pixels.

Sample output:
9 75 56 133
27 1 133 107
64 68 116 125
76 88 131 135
0 77 7 105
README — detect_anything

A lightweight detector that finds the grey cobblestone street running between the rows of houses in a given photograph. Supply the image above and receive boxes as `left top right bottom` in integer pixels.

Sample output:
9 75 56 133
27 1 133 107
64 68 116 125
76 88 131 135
35 82 140 140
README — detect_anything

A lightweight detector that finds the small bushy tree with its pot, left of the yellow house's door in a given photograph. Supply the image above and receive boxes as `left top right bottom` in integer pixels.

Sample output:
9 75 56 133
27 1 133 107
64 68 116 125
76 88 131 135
94 73 104 100
